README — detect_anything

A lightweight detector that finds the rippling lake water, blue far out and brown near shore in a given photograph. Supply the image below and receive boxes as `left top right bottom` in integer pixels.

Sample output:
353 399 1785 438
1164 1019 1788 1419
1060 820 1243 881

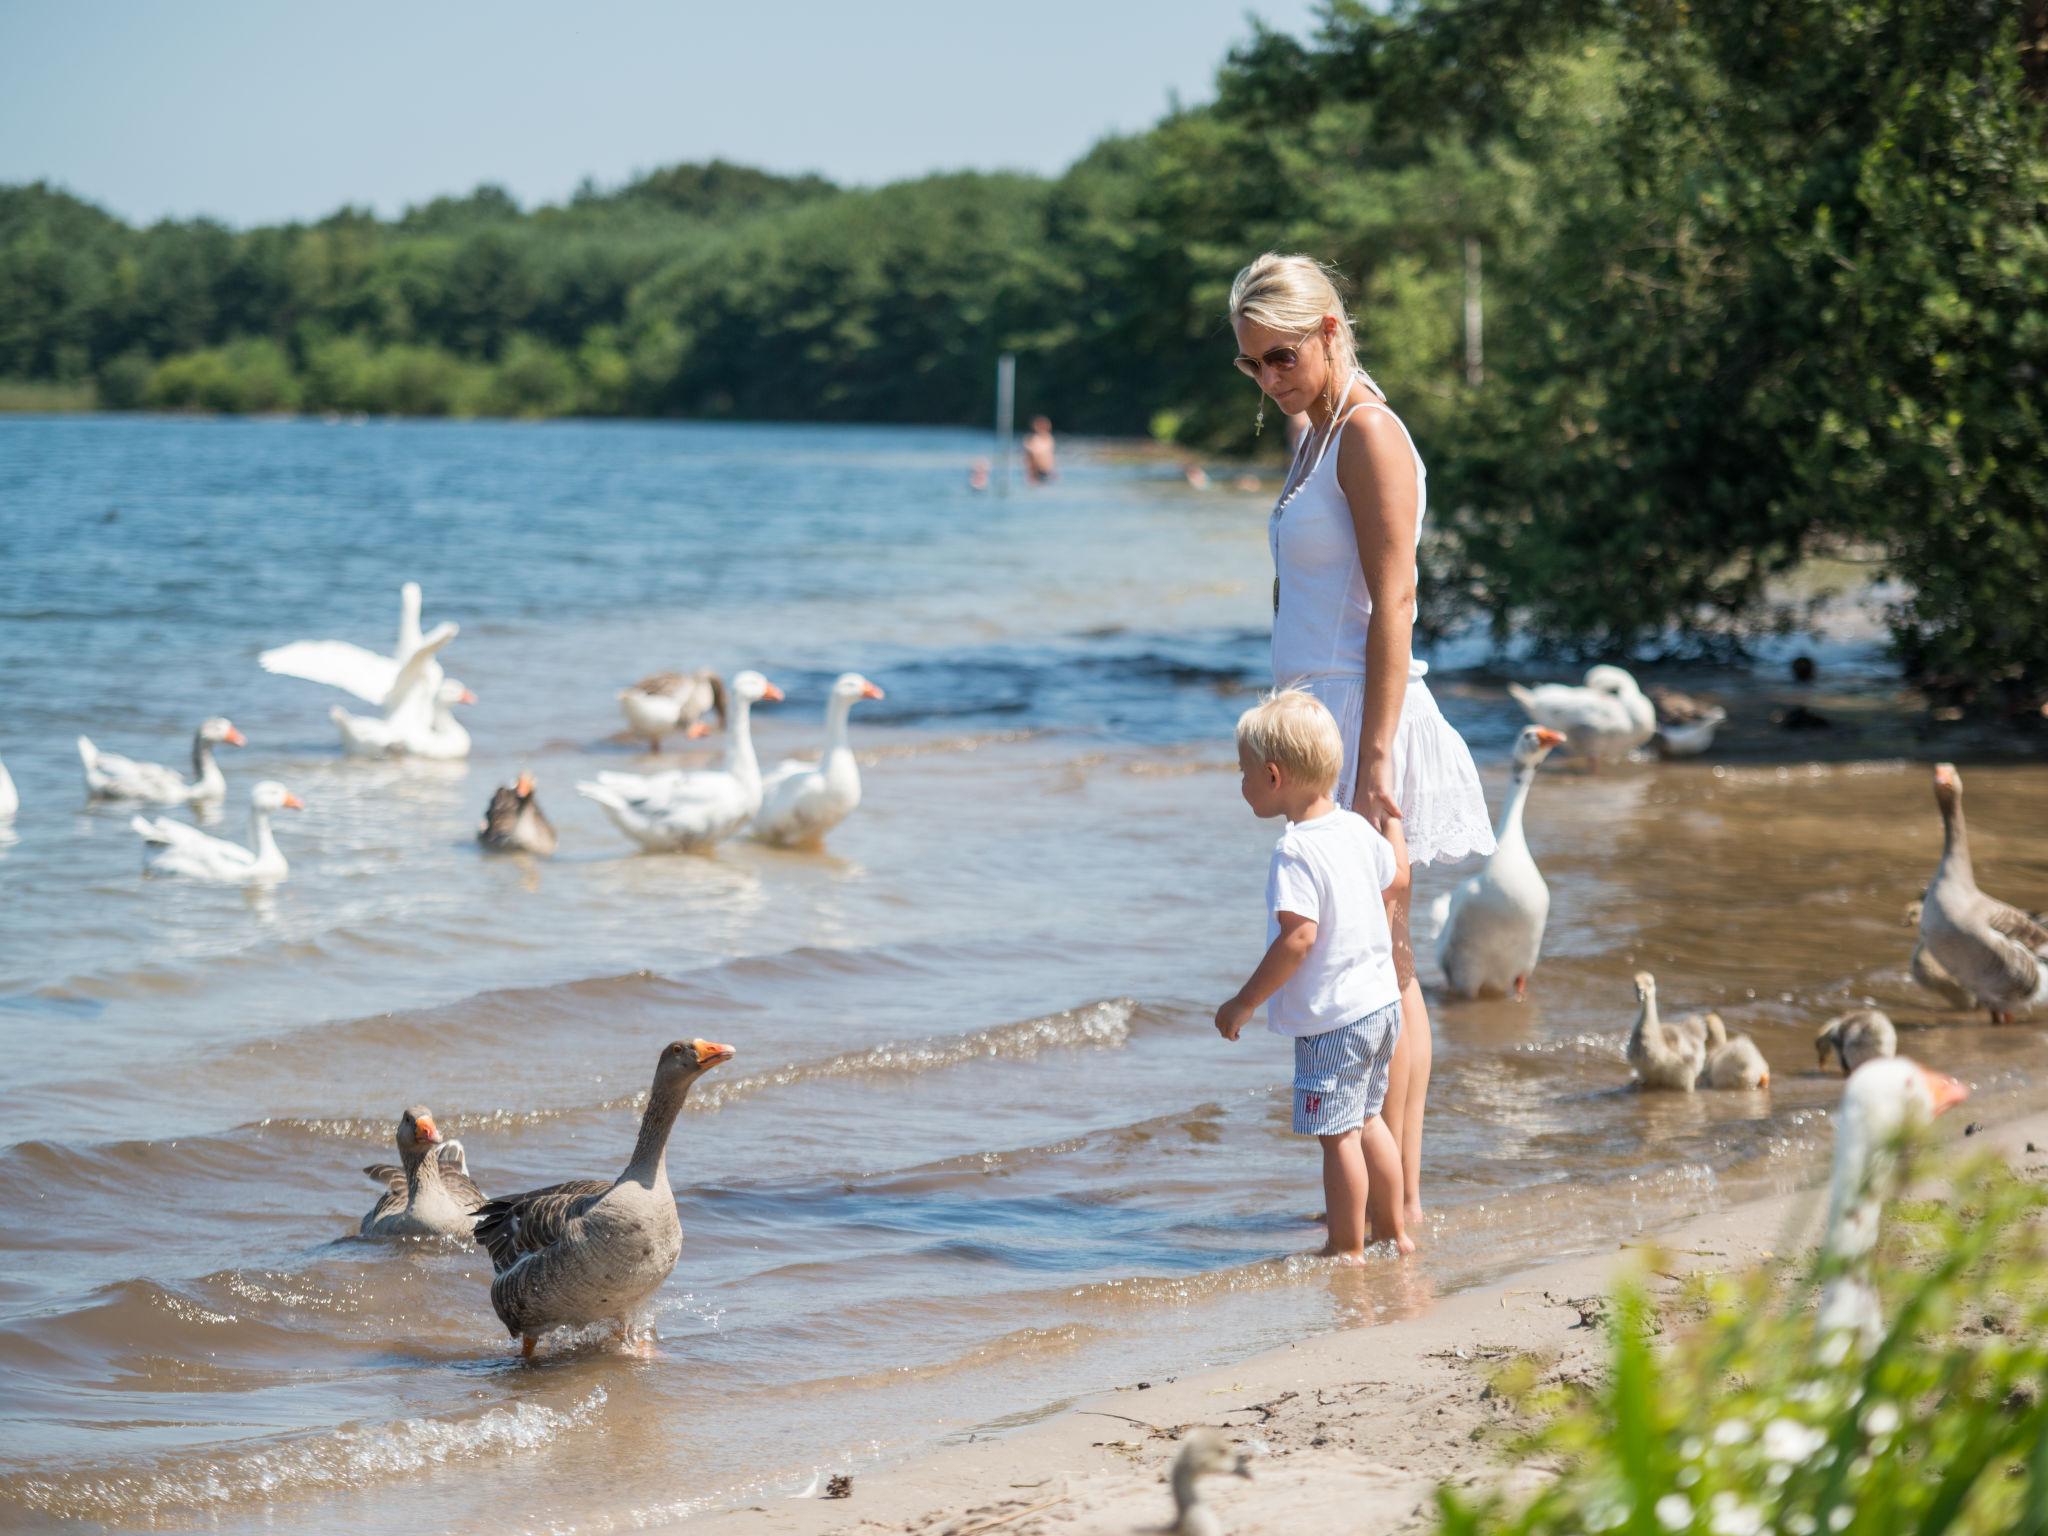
0 418 2048 1532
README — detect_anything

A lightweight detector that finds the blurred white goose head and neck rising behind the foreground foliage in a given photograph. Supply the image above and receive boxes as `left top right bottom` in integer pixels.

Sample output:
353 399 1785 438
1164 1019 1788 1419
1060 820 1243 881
1815 1057 1970 1364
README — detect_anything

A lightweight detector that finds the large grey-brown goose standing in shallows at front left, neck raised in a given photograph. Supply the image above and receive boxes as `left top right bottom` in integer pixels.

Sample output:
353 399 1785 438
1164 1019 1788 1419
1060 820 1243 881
475 1040 733 1360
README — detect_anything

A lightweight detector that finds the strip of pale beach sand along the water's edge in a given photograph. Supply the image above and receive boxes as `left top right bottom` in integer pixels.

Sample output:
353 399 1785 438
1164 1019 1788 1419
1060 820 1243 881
690 1106 2048 1536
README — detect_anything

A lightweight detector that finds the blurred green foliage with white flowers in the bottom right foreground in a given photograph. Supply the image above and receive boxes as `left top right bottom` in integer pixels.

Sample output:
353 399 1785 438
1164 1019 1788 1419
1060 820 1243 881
1438 1159 2048 1536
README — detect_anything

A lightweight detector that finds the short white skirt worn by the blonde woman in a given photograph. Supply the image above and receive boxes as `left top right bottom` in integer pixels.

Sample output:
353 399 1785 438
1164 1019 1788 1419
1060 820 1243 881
1292 662 1493 864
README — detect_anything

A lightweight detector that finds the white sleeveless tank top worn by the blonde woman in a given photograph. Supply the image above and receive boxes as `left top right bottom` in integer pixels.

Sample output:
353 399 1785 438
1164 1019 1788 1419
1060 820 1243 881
1266 369 1430 686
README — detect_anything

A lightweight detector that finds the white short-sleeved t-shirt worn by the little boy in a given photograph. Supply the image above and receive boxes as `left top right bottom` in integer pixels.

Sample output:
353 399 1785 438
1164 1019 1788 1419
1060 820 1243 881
1266 811 1401 1038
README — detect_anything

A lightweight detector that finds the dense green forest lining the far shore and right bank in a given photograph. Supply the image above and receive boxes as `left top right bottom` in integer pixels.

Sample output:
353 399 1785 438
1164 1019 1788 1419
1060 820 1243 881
0 0 2048 715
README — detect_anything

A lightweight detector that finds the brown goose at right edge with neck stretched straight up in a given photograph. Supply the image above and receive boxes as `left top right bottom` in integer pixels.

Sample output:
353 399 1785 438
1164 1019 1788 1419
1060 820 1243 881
1921 762 2048 1024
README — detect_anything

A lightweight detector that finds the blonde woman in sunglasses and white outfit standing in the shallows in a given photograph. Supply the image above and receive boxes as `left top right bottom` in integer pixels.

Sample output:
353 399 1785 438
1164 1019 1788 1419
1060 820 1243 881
1231 254 1493 1233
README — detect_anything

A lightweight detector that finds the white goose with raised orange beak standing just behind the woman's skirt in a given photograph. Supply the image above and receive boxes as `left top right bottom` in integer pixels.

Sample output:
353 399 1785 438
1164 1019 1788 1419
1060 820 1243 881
1436 725 1565 1001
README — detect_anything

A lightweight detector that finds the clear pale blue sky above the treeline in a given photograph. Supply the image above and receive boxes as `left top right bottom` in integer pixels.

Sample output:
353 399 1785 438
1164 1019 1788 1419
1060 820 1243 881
0 0 1317 225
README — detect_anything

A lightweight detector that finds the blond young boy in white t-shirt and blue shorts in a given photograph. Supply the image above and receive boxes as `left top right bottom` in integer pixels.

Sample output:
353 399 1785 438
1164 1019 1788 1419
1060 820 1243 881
1217 688 1415 1262
